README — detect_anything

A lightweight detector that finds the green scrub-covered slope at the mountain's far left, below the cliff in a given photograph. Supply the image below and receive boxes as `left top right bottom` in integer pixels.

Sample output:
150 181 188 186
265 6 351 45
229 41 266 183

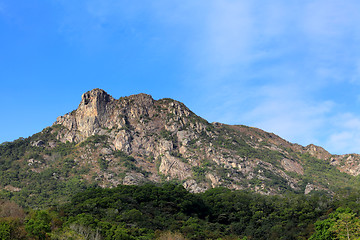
0 125 95 208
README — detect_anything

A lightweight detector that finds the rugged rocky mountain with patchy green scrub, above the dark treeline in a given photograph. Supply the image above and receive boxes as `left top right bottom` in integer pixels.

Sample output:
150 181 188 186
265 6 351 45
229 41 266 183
0 89 360 205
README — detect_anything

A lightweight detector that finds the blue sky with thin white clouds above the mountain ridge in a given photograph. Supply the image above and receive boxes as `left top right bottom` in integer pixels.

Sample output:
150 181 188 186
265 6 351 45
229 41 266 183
0 0 360 154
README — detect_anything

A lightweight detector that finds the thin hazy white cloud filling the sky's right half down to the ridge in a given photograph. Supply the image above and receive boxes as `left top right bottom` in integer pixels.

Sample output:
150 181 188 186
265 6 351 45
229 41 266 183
184 0 360 152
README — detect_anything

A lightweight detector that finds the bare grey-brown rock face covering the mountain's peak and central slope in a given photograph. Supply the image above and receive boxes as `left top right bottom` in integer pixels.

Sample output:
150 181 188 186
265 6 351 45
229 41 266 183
46 89 360 194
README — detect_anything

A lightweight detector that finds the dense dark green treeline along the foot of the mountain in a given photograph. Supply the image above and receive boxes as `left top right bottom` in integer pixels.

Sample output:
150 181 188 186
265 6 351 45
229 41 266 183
0 184 360 240
